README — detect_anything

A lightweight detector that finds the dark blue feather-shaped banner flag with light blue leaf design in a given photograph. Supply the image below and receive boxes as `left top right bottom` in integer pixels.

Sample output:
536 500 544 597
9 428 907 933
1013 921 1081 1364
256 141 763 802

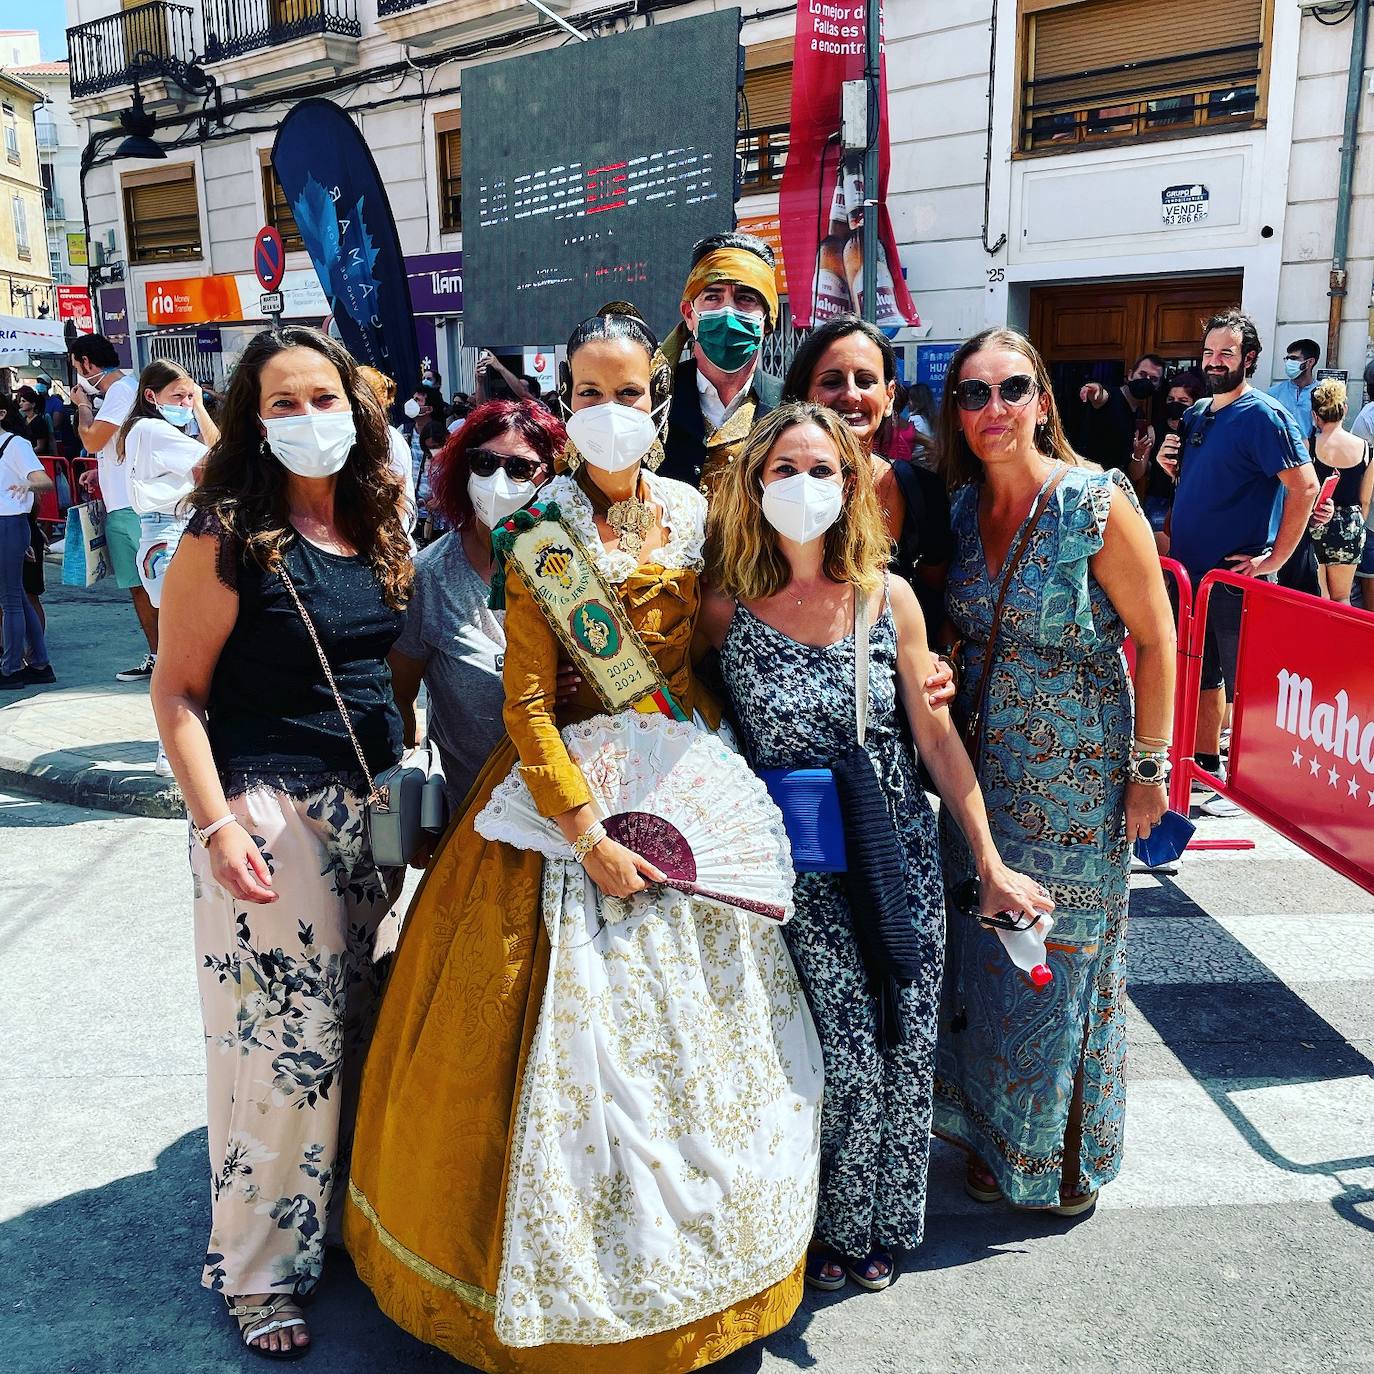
272 99 420 394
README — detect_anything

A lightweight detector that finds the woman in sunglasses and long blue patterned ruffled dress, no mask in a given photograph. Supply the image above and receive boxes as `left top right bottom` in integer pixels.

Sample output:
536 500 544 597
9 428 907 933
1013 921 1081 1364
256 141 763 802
934 330 1175 1216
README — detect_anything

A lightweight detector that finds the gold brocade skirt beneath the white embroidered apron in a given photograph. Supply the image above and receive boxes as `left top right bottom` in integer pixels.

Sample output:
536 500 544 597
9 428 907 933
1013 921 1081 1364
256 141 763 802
344 741 802 1374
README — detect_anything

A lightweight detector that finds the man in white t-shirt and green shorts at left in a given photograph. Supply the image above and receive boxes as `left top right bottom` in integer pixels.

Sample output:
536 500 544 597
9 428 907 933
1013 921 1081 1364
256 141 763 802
71 334 158 683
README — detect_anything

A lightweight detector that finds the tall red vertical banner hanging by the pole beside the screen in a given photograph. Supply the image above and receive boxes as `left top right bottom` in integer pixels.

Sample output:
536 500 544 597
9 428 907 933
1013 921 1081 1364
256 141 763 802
778 0 921 330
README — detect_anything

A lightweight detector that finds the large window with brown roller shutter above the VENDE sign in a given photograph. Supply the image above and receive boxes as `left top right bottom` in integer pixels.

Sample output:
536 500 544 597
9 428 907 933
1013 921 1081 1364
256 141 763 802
1020 0 1272 153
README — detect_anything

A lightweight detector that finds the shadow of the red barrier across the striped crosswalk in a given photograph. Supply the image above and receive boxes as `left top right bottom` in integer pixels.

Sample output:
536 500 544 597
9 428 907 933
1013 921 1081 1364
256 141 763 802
1129 878 1374 1231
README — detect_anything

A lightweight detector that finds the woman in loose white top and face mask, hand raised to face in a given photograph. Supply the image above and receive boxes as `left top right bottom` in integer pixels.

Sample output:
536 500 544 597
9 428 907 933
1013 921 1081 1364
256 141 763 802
115 357 220 606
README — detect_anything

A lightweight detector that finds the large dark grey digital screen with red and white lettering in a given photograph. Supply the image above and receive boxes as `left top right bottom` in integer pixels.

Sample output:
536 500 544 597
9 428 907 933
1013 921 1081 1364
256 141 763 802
463 10 741 349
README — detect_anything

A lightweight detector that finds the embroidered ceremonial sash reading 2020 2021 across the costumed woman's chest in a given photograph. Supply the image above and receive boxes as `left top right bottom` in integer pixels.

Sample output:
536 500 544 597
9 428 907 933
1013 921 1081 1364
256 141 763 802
492 502 687 720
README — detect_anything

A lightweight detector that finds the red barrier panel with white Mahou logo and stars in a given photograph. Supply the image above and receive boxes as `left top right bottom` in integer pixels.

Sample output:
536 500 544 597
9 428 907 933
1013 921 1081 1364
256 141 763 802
1230 587 1374 874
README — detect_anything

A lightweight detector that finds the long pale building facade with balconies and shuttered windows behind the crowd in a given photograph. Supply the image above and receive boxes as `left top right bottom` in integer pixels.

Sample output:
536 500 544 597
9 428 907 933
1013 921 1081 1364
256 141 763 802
69 0 1374 396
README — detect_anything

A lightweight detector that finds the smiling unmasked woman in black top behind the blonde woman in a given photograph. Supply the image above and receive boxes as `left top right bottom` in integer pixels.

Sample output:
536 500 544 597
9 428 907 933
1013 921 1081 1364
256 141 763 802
782 315 954 647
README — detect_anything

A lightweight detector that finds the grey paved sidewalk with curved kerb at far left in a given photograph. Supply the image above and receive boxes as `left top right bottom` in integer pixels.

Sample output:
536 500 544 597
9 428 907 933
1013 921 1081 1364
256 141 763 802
0 551 184 818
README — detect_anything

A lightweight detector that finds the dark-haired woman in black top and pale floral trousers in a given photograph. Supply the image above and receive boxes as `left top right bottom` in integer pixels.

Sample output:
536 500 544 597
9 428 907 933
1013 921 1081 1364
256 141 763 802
153 327 412 1358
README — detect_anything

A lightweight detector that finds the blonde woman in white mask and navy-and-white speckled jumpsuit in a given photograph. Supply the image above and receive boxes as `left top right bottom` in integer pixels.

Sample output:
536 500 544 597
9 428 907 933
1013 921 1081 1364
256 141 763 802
701 401 1050 1289
